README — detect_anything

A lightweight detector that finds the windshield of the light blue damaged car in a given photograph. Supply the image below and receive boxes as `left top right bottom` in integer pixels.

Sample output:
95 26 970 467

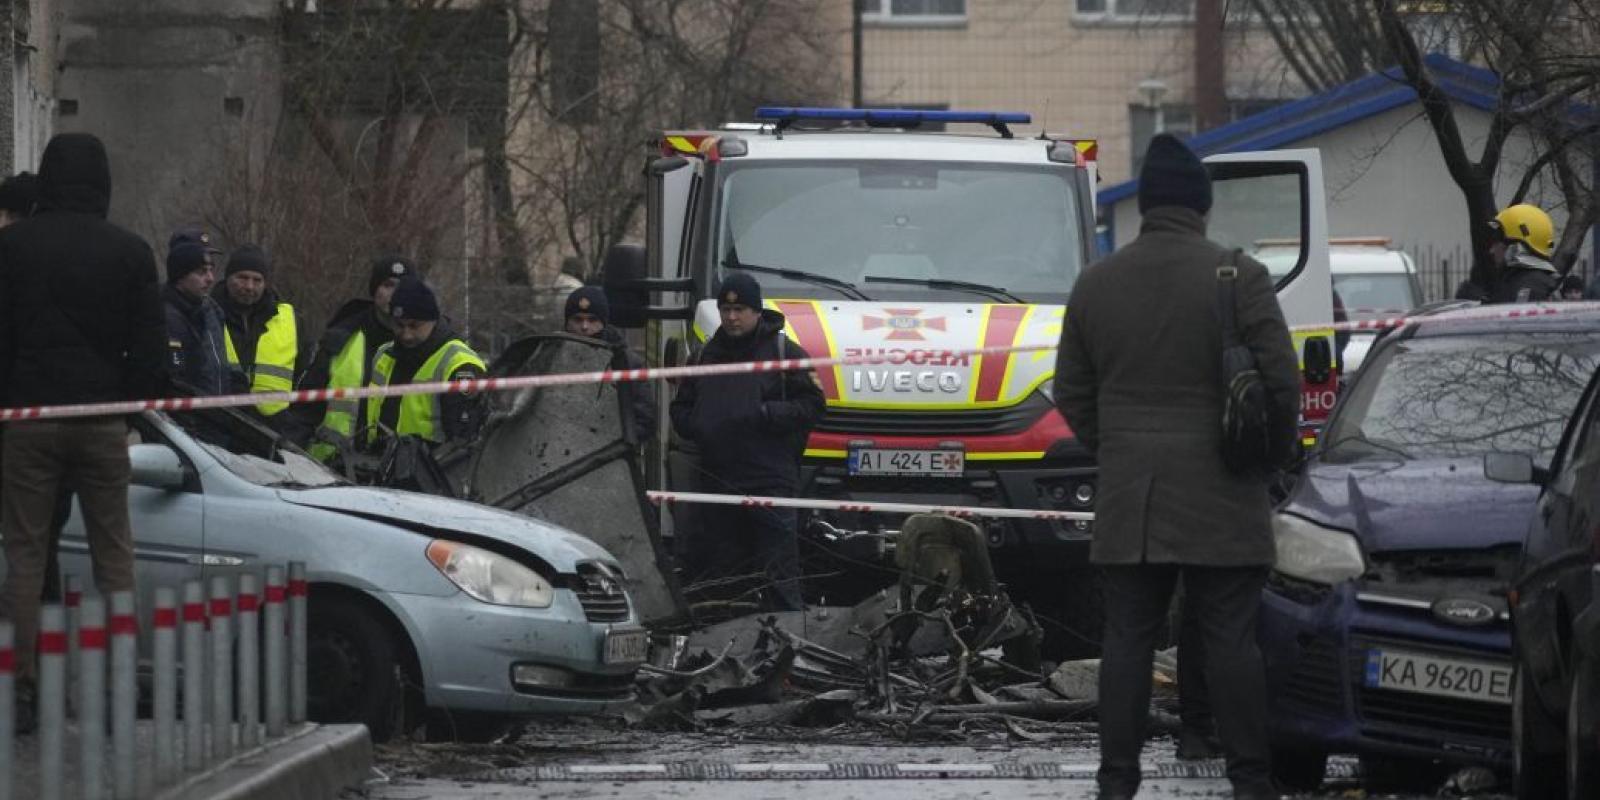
168 408 347 488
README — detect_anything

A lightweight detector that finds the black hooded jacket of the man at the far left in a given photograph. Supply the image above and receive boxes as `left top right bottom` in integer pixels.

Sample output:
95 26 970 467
0 134 166 406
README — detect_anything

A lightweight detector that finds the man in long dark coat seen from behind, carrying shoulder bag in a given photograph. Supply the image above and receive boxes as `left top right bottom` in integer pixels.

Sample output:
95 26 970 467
1054 134 1299 798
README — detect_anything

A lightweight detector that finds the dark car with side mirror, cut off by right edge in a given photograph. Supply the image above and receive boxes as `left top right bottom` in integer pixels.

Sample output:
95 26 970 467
1491 360 1600 800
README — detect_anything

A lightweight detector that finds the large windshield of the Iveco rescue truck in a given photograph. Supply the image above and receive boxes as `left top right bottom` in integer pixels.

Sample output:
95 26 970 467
714 162 1083 302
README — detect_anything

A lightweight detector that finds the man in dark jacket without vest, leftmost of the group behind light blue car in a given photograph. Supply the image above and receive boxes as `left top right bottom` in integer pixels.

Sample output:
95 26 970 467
162 235 235 395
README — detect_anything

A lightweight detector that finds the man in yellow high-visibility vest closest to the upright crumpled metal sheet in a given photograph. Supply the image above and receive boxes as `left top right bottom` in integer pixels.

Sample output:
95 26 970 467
366 278 488 445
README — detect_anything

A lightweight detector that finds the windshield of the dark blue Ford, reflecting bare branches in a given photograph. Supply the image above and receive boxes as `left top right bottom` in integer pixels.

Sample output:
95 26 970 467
1323 331 1600 464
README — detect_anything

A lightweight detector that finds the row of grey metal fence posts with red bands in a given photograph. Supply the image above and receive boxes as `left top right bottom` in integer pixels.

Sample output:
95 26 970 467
0 562 307 800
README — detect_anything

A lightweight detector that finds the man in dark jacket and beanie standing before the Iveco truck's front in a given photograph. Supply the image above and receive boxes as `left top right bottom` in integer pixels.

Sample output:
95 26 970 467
672 272 824 610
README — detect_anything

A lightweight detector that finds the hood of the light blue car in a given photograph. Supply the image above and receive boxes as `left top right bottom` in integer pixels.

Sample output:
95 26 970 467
278 486 618 573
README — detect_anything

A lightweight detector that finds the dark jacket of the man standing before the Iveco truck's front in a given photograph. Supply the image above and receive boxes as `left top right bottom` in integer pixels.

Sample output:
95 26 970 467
672 309 824 493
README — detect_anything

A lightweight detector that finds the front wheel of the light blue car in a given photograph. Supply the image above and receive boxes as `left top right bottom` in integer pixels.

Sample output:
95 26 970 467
306 600 403 742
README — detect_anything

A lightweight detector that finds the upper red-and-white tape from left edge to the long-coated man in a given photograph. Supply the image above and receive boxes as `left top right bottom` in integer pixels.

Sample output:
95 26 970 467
0 344 1056 422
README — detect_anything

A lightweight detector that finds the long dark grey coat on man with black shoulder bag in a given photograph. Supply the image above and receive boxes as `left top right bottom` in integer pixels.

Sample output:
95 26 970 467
1054 206 1299 566
